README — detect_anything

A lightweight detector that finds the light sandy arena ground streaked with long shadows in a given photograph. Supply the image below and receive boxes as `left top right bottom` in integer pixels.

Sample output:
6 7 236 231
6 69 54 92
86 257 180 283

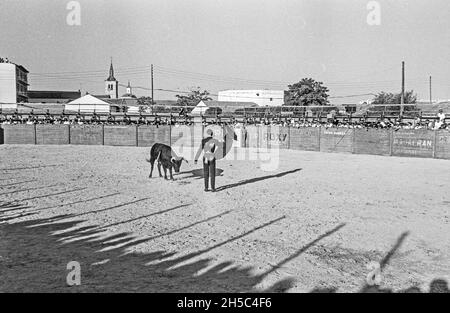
0 145 450 292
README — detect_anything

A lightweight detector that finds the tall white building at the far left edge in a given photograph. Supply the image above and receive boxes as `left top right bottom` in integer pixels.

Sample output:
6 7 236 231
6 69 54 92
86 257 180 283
0 63 28 108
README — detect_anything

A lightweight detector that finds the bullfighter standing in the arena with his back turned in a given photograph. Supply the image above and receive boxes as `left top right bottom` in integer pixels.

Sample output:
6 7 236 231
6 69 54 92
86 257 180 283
194 129 220 192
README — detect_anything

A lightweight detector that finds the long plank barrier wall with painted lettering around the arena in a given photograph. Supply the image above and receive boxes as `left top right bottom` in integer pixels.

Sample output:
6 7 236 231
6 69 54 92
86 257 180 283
0 124 450 159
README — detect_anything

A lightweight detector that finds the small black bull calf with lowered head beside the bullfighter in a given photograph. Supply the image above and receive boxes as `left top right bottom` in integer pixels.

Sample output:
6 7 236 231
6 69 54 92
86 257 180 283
147 143 188 180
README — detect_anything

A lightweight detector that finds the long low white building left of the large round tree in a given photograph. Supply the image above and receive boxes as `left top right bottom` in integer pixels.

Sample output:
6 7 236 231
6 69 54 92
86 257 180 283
218 89 284 106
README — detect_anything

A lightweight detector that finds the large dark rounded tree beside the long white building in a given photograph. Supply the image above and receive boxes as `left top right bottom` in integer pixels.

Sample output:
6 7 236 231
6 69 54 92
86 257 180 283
285 78 329 106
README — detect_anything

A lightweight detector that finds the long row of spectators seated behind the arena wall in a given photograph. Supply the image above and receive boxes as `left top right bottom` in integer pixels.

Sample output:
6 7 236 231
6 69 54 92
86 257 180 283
0 110 450 130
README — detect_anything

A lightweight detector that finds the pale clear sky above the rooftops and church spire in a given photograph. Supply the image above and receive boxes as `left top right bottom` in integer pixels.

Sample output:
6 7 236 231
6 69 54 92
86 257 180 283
0 0 450 103
